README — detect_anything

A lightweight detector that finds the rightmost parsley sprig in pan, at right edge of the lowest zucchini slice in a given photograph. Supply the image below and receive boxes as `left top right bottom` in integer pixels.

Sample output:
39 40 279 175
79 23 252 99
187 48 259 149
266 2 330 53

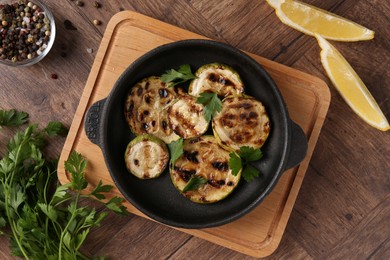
229 146 263 182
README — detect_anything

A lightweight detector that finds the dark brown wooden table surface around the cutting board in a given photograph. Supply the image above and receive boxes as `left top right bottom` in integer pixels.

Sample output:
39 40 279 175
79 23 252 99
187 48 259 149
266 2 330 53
0 0 390 259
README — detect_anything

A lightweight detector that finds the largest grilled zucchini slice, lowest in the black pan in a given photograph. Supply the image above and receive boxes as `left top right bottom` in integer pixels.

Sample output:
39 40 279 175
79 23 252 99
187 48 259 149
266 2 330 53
170 135 241 203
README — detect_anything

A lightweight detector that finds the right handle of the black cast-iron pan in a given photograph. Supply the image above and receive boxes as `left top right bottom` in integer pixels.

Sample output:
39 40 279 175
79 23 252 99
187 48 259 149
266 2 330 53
285 121 308 170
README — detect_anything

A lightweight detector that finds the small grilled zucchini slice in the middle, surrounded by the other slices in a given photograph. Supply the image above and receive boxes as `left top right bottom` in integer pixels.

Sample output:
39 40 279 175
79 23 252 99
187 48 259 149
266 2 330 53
168 93 209 139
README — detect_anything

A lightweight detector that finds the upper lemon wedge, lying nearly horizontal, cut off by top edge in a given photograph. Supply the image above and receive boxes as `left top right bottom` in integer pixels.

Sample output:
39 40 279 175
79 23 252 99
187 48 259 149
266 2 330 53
267 0 374 42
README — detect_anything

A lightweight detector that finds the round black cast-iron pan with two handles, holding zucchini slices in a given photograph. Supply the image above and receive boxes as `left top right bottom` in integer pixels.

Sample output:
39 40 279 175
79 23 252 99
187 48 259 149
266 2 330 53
85 39 307 228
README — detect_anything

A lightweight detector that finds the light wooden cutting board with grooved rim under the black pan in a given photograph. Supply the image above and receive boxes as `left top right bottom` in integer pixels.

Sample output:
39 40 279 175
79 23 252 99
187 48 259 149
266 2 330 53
58 11 330 257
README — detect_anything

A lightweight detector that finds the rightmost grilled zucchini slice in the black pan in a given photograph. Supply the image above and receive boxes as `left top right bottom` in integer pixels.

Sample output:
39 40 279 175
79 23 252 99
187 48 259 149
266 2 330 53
212 95 270 151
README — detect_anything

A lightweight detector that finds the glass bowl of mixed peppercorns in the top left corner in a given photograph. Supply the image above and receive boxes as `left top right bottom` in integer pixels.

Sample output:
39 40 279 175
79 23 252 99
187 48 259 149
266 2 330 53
0 0 56 67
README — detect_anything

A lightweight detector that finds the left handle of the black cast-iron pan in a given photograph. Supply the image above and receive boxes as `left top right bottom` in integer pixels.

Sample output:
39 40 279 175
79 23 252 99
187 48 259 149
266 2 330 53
84 99 106 146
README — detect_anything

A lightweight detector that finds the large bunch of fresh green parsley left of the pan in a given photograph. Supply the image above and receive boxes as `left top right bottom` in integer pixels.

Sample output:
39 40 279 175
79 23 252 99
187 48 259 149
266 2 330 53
0 110 127 259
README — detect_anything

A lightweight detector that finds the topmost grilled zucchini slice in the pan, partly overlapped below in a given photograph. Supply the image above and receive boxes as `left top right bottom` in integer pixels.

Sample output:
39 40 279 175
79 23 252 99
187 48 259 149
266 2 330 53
188 63 244 97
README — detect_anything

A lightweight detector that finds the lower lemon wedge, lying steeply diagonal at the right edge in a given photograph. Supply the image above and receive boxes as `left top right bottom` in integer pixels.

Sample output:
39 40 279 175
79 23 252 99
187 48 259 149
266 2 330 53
315 35 390 131
